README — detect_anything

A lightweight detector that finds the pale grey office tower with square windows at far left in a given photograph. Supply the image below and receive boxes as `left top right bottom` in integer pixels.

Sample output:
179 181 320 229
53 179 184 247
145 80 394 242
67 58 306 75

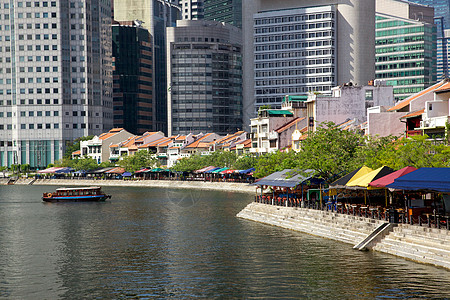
0 0 113 169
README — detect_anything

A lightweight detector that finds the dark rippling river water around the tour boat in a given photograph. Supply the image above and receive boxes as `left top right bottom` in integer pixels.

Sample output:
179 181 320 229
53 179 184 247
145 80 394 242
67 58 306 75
0 186 450 299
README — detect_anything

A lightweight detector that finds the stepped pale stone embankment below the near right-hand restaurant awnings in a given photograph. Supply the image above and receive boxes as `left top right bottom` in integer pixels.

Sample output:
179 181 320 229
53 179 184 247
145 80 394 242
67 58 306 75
237 202 450 269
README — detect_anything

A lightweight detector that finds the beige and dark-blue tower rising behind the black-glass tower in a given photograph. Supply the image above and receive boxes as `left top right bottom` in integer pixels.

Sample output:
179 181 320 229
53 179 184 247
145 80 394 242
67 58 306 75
114 0 180 132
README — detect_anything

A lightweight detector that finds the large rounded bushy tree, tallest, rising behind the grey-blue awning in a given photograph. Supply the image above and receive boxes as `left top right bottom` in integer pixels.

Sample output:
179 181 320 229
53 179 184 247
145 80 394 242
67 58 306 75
298 122 363 181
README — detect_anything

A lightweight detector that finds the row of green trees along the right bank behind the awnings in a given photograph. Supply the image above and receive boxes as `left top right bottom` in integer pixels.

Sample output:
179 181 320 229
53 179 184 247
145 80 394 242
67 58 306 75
174 123 450 182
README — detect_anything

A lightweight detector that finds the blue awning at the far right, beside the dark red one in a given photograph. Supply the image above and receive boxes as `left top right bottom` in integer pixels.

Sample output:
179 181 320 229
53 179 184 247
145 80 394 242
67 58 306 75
386 168 450 193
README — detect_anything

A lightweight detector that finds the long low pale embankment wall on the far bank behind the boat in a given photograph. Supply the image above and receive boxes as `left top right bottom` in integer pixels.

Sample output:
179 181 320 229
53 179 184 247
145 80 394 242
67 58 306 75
15 179 256 193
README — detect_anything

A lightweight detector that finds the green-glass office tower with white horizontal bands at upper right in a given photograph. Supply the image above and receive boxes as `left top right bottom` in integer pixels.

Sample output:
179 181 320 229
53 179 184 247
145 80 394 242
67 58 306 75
376 0 436 100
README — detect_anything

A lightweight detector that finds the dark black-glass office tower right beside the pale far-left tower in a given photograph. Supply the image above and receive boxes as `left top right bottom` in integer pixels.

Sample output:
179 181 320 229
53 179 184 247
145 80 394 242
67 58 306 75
112 21 153 134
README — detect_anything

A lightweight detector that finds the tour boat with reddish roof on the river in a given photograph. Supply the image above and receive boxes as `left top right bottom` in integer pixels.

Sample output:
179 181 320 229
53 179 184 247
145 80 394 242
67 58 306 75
42 186 111 202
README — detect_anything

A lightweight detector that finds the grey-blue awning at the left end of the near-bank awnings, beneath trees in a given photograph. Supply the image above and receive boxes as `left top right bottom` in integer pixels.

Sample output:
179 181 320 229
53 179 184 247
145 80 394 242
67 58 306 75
252 169 315 188
